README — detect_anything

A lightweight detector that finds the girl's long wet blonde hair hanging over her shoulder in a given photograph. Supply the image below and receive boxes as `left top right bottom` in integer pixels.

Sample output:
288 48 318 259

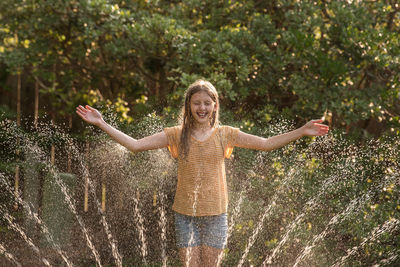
179 80 219 159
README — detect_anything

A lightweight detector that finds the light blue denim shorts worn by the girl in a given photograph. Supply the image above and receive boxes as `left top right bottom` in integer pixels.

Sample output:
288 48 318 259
175 212 228 249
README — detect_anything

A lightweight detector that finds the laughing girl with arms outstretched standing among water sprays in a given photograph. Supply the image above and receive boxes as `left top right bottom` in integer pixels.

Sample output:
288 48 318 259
76 80 329 266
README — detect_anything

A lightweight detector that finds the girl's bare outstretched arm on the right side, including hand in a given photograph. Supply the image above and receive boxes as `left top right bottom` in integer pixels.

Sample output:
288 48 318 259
235 120 329 151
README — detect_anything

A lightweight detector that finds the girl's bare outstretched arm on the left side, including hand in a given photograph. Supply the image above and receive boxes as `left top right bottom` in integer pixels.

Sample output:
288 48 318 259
76 105 168 152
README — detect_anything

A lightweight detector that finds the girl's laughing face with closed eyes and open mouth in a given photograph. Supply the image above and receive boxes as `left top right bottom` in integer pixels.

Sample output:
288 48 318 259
190 91 217 126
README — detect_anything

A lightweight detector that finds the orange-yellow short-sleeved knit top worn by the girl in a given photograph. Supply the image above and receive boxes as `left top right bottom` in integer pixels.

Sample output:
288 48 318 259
164 126 239 216
